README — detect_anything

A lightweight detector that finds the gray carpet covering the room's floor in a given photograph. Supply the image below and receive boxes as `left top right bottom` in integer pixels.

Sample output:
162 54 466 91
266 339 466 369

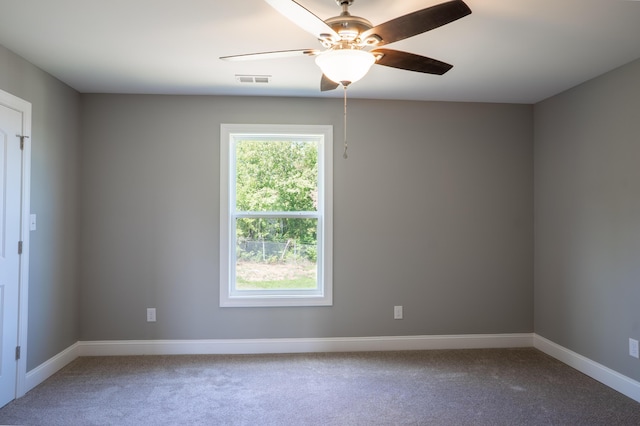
0 348 640 425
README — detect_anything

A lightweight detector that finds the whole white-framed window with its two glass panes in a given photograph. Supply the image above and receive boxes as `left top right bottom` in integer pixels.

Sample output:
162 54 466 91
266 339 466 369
220 124 333 306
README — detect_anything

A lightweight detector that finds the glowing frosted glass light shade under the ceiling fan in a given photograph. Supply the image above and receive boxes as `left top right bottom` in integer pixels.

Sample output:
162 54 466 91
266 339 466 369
316 49 376 86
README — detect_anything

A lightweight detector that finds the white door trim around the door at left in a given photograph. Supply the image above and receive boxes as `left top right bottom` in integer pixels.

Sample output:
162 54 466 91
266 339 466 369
0 90 32 398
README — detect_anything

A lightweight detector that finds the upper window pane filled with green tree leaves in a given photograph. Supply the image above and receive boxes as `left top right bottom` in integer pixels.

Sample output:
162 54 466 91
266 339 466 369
235 139 318 212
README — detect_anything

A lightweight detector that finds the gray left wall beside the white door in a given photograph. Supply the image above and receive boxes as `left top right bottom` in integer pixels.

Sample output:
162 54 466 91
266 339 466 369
0 46 80 370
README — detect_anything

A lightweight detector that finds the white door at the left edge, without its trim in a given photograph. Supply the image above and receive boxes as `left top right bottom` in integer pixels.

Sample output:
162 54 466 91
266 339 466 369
0 105 22 407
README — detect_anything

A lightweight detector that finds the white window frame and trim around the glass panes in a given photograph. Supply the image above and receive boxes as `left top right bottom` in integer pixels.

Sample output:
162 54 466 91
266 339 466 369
220 124 333 307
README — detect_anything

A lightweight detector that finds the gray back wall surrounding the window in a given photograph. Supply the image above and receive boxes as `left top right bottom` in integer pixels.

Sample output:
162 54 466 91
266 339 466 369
79 94 533 340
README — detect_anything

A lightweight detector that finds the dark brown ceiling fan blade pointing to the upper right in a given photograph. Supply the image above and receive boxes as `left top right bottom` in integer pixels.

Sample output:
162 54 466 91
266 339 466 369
361 0 471 46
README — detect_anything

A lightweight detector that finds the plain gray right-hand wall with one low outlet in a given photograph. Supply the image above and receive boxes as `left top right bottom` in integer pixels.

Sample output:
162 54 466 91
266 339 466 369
534 56 640 380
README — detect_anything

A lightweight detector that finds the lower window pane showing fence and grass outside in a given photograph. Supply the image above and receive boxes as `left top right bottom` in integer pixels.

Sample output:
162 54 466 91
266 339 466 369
235 218 318 291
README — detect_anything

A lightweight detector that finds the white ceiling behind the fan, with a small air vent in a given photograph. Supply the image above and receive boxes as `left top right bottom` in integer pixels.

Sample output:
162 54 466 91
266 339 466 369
0 0 640 104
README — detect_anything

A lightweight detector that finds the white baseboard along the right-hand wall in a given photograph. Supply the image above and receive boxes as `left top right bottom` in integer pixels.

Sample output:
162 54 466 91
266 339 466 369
533 334 640 402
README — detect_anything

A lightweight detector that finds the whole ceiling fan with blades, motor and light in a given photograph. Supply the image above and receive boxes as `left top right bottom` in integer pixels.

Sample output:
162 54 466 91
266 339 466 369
220 0 471 91
